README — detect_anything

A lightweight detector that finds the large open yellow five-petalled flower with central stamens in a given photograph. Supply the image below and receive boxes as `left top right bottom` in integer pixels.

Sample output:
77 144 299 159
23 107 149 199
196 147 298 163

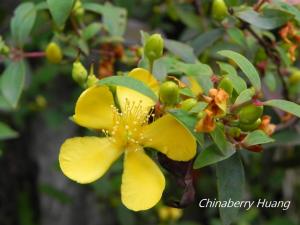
59 68 196 211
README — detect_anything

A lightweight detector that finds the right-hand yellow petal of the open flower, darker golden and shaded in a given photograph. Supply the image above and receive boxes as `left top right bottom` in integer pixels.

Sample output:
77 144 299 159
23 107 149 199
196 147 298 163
143 114 196 161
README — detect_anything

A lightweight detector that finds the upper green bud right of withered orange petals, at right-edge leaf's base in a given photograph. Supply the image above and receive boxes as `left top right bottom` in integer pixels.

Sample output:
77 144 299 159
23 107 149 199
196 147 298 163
238 104 264 124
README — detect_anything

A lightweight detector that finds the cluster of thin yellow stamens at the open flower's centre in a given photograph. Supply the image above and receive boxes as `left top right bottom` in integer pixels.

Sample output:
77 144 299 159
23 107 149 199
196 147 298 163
103 99 155 147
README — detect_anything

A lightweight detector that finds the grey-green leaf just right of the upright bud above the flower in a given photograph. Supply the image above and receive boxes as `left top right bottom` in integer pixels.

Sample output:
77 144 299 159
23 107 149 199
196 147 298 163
164 39 197 63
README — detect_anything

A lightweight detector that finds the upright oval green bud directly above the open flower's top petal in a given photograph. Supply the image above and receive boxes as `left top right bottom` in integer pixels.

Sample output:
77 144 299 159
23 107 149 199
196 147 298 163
144 34 164 61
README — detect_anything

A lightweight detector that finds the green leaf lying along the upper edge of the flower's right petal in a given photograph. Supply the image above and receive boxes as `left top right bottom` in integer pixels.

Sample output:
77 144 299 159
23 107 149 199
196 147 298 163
169 109 204 146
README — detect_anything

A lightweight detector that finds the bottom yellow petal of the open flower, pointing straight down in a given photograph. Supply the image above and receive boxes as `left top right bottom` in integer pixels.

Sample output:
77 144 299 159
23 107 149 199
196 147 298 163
121 146 165 211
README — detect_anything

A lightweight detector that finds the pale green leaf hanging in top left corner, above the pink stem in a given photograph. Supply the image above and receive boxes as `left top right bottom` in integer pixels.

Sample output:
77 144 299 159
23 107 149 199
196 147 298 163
10 2 36 47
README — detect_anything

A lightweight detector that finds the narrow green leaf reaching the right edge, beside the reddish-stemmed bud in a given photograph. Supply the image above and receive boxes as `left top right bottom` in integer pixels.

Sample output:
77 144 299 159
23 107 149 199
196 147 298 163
264 99 300 117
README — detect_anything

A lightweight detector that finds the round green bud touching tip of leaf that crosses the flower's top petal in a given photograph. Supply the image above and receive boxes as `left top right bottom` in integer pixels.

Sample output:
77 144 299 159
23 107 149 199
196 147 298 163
159 81 179 106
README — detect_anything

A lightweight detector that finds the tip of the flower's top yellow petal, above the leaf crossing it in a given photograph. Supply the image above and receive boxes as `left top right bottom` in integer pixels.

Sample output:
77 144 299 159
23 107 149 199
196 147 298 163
128 68 159 94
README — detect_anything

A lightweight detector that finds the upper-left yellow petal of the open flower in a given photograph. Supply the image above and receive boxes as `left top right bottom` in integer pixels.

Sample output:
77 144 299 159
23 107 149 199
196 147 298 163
73 86 114 129
